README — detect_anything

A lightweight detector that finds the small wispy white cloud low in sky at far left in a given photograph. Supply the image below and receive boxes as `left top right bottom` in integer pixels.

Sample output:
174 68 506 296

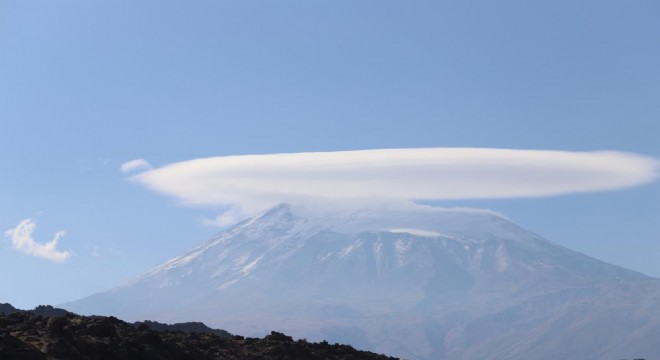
5 219 71 263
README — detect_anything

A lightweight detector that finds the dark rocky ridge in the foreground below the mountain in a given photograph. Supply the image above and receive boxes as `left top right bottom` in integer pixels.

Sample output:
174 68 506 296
0 311 395 360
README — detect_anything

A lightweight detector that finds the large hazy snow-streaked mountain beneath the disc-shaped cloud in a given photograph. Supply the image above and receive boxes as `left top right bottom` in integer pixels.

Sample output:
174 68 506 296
62 205 660 360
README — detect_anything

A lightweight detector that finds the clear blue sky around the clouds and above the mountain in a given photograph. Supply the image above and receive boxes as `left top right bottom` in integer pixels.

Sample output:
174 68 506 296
0 0 660 308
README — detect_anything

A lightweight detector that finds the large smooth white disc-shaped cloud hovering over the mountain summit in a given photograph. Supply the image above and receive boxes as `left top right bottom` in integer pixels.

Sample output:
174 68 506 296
133 148 659 215
